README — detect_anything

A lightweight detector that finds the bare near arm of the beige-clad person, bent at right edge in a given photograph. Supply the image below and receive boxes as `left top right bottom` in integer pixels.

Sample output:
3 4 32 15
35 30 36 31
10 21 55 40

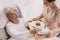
45 11 60 35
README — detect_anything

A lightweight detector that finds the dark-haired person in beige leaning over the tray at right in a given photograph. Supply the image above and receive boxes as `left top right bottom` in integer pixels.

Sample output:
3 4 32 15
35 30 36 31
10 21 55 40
29 0 60 37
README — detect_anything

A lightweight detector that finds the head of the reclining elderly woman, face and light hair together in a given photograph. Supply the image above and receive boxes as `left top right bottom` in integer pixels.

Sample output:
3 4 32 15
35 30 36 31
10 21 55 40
7 9 18 23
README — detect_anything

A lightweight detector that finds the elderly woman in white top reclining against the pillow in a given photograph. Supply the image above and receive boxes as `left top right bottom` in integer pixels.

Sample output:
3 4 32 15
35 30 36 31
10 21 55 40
5 7 34 40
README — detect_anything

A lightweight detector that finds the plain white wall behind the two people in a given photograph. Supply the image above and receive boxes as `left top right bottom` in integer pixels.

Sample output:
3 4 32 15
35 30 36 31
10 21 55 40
0 0 60 19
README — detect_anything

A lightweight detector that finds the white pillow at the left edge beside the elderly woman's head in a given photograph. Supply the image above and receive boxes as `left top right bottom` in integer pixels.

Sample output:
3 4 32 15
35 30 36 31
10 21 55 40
0 10 8 28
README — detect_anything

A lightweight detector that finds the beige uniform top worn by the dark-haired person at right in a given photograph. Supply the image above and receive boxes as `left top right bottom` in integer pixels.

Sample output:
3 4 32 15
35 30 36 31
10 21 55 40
43 6 60 29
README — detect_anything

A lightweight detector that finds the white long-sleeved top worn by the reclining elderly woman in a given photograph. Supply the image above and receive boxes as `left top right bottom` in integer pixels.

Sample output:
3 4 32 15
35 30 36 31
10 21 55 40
6 18 34 40
